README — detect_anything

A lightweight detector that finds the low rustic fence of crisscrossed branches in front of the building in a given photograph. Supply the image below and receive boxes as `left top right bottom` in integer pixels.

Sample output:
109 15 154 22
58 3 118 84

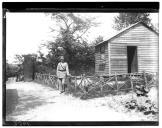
35 72 158 94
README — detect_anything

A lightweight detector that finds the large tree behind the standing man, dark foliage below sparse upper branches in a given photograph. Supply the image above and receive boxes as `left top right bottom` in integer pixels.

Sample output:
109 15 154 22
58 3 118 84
41 13 97 75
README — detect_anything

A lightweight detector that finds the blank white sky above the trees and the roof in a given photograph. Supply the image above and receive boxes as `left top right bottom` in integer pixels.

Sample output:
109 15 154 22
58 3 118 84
6 12 158 63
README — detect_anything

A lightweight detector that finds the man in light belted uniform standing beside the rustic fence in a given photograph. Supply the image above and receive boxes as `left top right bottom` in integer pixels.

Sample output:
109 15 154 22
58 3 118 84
56 56 69 93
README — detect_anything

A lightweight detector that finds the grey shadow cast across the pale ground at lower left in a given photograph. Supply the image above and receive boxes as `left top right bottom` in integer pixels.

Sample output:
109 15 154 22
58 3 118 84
6 89 55 120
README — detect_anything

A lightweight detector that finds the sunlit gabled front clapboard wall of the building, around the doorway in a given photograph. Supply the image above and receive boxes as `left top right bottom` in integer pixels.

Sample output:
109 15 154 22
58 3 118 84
109 24 158 74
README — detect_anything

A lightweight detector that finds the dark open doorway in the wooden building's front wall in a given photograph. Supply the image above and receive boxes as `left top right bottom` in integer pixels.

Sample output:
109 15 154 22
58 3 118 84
127 46 138 73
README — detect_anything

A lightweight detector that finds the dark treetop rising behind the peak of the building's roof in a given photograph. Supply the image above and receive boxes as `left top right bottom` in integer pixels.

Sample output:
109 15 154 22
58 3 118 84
113 13 151 30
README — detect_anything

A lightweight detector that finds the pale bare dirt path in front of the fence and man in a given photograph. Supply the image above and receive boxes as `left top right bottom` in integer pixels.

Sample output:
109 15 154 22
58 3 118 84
6 82 153 121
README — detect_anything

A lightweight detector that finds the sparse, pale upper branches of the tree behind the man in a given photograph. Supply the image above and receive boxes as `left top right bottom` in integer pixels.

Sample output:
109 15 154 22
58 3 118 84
50 13 98 41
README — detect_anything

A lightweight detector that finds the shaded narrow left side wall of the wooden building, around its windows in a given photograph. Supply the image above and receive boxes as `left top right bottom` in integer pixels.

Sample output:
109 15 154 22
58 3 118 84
95 42 109 75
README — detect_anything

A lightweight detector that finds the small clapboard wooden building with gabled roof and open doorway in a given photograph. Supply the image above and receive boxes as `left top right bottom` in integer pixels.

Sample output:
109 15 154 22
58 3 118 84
95 22 159 75
